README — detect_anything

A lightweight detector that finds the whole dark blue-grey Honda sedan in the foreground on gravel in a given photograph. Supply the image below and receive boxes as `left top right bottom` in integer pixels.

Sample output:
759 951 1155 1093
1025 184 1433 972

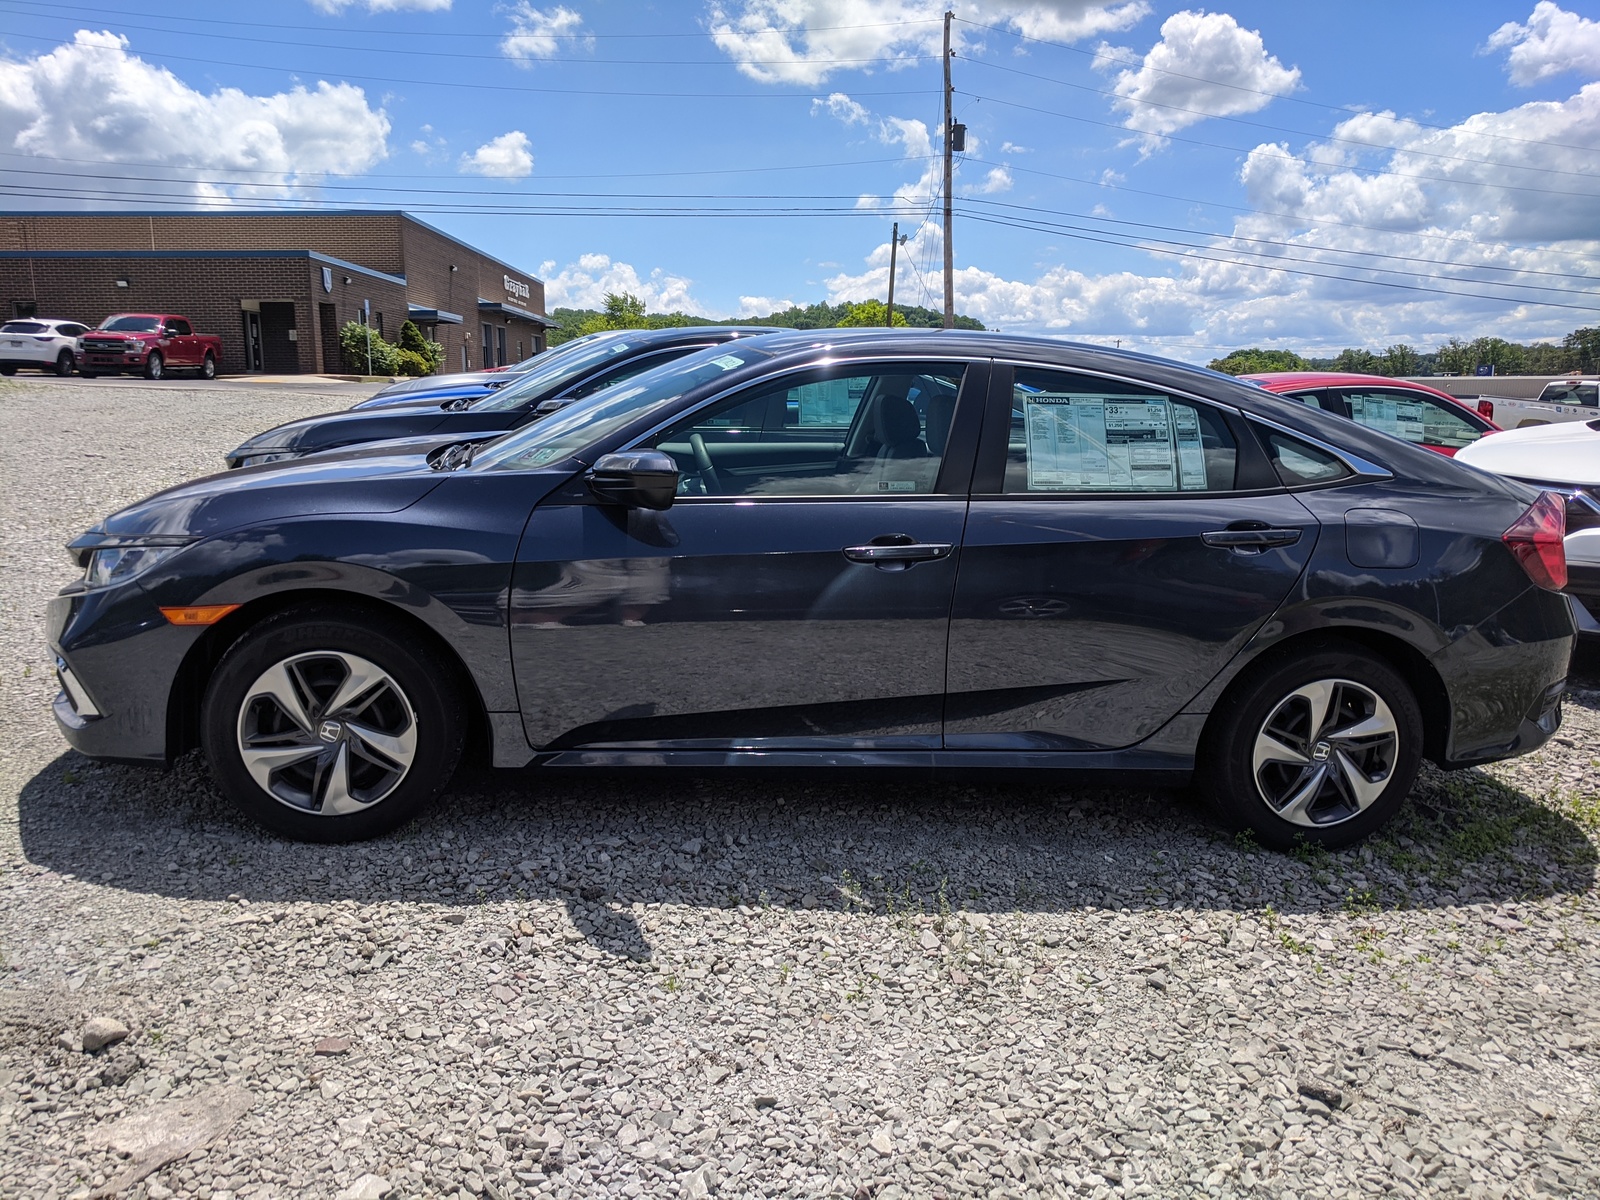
50 330 1574 846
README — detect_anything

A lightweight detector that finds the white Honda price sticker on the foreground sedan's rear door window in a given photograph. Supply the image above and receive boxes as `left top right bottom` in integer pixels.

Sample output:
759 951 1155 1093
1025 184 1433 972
1021 392 1206 491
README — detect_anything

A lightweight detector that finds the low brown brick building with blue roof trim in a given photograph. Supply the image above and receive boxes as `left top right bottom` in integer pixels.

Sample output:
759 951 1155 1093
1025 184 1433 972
0 210 554 374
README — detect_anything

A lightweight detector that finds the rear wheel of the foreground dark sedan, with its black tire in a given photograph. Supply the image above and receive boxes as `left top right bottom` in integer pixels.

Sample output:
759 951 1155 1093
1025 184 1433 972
1197 643 1422 850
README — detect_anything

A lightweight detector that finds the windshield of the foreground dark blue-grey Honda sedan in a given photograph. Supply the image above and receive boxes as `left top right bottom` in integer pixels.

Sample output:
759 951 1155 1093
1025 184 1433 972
474 342 771 470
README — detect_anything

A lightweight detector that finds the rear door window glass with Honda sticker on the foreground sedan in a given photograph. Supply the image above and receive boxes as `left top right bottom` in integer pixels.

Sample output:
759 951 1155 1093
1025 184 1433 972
1003 368 1238 493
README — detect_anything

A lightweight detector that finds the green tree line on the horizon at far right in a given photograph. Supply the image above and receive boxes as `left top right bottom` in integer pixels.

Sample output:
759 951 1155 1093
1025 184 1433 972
1210 330 1600 376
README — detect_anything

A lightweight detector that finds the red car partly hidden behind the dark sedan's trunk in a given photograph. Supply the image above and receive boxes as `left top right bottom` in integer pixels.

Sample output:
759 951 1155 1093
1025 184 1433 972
1240 371 1499 456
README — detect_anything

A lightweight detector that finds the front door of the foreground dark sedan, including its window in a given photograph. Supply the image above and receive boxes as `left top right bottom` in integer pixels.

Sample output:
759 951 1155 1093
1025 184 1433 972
510 360 987 752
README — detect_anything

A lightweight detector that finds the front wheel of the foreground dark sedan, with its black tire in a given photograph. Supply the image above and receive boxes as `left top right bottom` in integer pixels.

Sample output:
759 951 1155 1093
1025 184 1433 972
200 608 466 842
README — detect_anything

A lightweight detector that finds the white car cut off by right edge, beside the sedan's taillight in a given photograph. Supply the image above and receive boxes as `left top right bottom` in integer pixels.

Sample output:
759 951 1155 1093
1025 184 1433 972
1456 418 1600 635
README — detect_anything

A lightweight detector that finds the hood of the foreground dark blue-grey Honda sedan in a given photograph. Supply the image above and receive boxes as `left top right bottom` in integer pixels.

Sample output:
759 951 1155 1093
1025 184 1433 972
80 453 448 541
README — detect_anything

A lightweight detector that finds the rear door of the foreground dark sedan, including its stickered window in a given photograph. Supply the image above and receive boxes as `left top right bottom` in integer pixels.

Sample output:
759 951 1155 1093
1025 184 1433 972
946 365 1320 750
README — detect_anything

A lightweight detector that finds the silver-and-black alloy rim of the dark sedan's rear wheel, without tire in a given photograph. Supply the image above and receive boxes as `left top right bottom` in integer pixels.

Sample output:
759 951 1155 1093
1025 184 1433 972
1251 678 1400 826
